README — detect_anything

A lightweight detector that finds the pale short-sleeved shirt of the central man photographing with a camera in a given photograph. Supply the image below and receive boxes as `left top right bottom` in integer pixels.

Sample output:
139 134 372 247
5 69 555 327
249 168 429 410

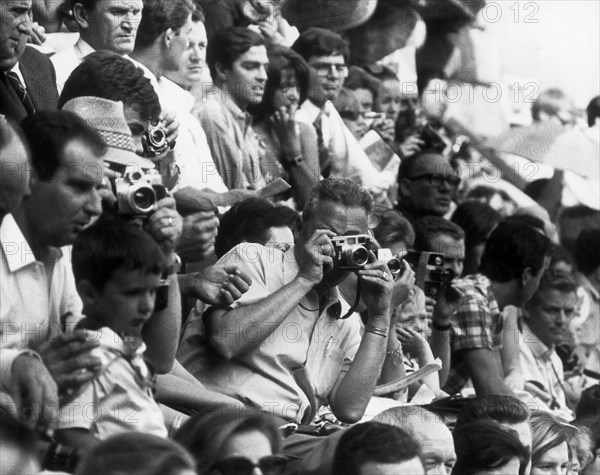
190 243 362 422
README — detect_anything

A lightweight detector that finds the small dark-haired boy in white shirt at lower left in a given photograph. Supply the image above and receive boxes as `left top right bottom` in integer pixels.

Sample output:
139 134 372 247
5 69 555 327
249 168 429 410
56 219 167 450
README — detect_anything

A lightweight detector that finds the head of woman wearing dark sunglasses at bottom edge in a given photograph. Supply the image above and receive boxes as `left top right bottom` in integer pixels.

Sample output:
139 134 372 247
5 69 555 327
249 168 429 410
175 410 286 475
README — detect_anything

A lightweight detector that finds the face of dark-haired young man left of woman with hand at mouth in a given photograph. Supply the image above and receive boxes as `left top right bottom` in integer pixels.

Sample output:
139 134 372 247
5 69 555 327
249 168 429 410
216 46 269 109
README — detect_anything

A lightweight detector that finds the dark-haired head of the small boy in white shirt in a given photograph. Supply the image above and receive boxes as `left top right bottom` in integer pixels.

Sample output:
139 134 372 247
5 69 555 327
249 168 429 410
72 219 164 336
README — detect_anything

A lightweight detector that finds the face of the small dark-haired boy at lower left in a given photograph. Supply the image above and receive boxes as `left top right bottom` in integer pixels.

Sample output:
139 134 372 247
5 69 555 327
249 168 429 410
83 269 160 338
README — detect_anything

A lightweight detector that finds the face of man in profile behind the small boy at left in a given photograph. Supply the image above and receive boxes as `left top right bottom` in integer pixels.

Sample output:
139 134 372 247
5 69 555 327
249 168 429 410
26 140 104 247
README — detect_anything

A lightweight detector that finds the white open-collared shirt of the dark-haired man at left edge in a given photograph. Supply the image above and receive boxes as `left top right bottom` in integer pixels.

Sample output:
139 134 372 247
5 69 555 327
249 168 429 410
0 214 82 390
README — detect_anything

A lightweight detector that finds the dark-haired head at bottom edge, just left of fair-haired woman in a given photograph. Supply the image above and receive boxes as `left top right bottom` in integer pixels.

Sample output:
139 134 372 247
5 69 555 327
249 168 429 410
452 421 529 475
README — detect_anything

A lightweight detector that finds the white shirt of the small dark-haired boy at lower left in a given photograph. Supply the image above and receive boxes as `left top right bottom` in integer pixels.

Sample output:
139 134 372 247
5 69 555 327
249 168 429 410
58 327 167 440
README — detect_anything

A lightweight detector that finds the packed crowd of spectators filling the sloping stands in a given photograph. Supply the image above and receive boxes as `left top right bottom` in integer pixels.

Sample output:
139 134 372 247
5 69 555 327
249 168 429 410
0 0 600 475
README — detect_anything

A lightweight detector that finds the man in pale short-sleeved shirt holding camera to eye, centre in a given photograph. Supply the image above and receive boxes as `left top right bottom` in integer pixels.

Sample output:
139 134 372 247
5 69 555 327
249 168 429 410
203 179 414 438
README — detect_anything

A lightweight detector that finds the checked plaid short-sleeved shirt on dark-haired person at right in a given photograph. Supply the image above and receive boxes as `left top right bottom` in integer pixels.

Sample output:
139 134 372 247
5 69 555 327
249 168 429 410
444 274 502 394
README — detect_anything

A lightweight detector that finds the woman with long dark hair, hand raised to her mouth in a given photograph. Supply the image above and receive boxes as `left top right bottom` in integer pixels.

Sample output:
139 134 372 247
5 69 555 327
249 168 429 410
253 45 321 209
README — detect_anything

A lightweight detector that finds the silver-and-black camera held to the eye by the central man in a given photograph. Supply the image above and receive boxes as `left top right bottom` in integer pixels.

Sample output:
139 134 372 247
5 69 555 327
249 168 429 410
331 234 402 277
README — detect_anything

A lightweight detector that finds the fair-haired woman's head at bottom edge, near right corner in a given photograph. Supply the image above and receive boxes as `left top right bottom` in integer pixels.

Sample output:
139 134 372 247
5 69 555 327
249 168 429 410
529 411 577 475
